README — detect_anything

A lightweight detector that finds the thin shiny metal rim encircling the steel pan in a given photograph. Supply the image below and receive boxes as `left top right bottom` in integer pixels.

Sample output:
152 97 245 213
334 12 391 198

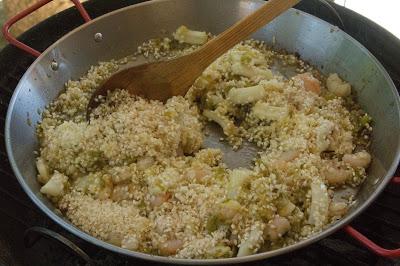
5 0 400 265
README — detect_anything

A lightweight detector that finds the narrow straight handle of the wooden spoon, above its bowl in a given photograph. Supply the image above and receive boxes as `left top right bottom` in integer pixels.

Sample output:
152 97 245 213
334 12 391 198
197 0 300 68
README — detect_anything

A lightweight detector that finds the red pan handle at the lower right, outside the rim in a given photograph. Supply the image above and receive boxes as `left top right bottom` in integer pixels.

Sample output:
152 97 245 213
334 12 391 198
344 177 400 258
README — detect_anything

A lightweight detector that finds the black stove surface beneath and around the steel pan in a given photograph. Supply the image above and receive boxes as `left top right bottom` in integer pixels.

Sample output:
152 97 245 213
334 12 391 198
0 0 400 266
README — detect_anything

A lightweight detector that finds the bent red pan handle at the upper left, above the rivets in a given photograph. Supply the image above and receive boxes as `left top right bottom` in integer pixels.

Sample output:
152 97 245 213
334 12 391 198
2 0 91 57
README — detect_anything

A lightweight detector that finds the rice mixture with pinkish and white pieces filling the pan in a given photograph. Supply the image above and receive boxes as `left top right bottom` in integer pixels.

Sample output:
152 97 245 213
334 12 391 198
37 26 372 259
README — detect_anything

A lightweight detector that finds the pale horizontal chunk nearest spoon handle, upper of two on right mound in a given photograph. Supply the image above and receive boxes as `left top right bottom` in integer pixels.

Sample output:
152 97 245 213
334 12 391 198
228 85 266 104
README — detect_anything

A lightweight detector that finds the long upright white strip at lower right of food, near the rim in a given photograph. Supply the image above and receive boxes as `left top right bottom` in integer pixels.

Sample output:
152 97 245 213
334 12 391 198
308 180 329 228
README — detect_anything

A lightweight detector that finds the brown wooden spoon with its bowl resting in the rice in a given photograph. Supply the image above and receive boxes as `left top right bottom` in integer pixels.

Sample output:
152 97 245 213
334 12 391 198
88 0 300 113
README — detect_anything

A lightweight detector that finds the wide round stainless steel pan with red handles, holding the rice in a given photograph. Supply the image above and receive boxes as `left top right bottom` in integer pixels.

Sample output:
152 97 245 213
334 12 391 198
5 0 400 264
